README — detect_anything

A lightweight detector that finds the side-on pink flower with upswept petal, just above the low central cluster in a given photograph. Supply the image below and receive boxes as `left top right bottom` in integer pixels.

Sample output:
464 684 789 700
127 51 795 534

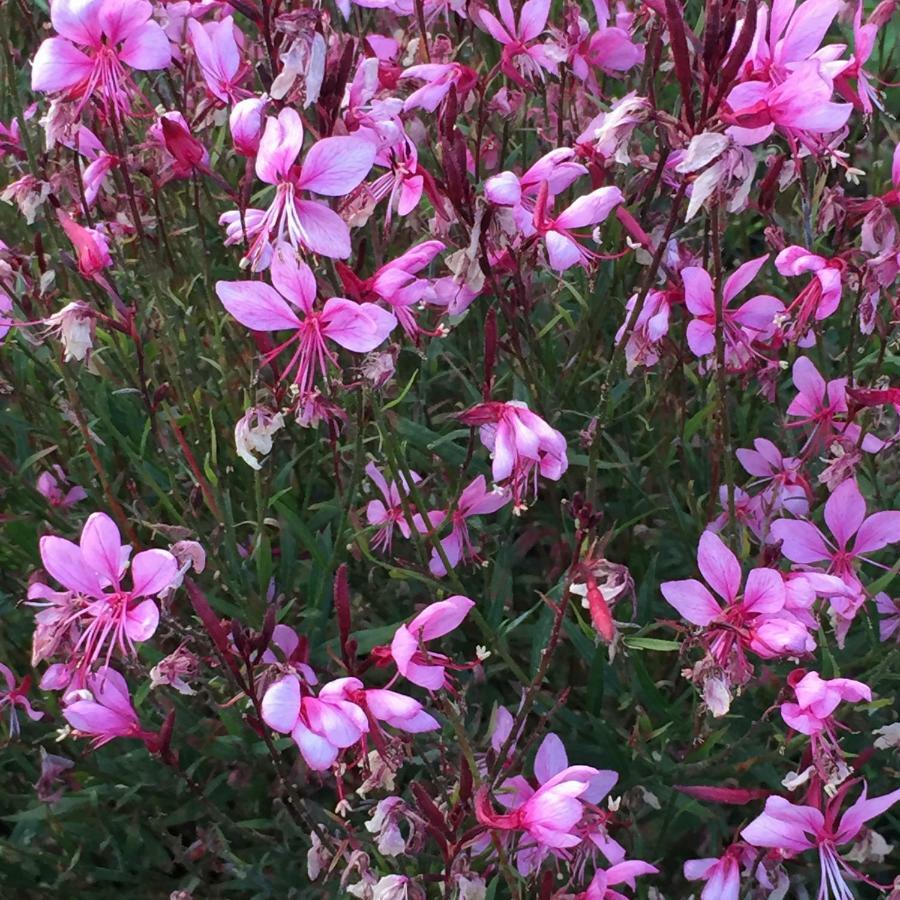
390 594 475 691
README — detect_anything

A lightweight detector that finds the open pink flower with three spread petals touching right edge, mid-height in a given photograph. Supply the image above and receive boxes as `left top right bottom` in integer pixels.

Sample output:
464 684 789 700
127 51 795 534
772 478 900 588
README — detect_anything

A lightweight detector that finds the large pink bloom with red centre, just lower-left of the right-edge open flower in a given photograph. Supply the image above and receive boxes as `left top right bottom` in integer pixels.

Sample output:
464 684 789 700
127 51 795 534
660 531 815 684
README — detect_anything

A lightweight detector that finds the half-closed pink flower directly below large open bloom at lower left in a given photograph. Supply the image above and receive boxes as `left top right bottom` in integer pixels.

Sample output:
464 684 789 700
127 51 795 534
62 666 151 747
